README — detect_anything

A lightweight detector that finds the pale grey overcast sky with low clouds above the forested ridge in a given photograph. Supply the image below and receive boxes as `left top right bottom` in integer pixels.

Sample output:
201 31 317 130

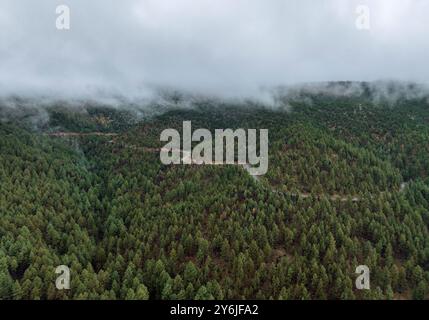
0 0 429 96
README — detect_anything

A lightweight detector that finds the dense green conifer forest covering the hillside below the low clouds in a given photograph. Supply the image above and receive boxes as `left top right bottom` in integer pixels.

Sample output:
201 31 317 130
0 84 429 300
